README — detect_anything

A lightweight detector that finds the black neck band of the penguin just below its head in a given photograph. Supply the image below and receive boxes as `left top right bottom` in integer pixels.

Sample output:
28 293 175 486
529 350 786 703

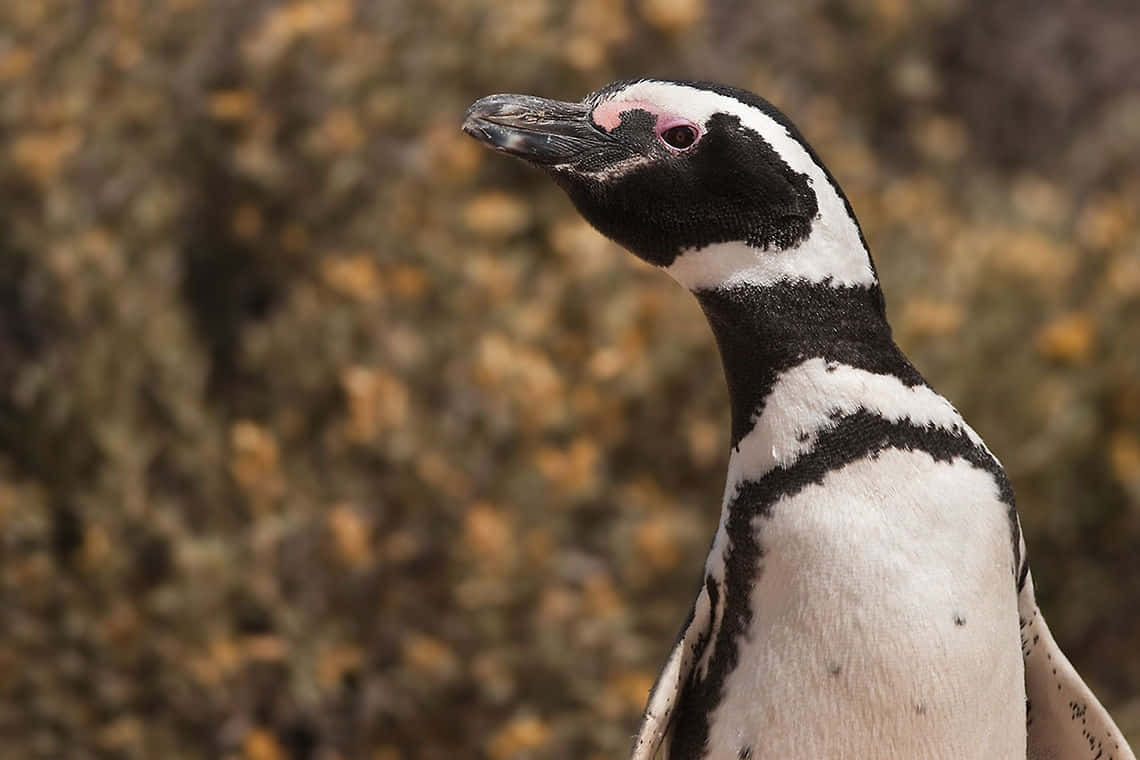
693 279 922 449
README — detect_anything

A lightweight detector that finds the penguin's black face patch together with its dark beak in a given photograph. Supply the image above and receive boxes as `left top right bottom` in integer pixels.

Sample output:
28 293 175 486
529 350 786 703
464 80 817 265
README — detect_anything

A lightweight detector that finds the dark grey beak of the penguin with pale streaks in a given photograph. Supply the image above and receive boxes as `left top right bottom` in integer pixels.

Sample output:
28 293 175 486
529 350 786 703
463 95 604 166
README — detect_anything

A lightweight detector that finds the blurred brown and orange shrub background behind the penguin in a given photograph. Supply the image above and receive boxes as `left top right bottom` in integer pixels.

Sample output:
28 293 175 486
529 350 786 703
0 0 1140 760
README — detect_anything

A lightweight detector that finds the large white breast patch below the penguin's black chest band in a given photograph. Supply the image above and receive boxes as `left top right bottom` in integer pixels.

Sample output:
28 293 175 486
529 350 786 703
708 450 1025 760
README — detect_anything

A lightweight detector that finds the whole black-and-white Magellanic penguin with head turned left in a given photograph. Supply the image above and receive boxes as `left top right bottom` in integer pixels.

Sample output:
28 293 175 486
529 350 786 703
463 80 1134 760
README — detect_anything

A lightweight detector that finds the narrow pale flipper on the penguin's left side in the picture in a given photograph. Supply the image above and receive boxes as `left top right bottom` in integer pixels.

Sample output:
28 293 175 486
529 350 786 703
629 588 713 760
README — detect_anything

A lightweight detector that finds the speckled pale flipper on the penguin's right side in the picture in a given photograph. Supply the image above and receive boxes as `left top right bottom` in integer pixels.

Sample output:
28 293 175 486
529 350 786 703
1018 567 1135 760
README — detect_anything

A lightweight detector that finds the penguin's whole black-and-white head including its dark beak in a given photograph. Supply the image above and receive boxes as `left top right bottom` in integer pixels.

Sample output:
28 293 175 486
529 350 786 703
463 80 874 291
